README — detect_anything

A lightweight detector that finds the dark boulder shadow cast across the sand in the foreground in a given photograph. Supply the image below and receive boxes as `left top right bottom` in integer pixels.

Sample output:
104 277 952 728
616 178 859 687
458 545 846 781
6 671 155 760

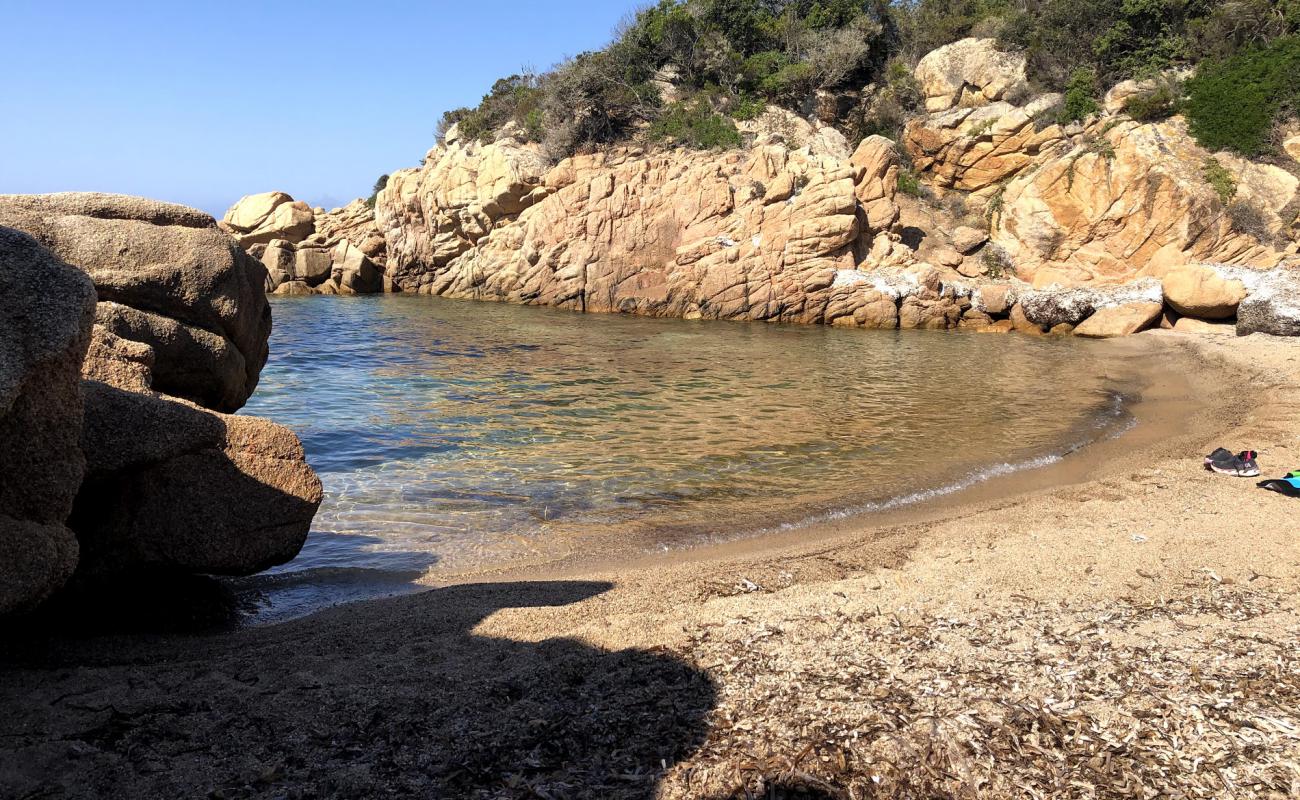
0 581 715 799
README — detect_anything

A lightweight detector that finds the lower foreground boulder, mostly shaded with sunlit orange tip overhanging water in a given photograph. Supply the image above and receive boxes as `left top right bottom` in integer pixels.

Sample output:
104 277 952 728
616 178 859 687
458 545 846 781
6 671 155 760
69 381 321 576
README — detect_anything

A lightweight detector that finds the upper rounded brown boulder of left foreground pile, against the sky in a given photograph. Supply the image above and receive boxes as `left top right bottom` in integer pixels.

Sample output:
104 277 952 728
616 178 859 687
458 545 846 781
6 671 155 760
0 194 270 411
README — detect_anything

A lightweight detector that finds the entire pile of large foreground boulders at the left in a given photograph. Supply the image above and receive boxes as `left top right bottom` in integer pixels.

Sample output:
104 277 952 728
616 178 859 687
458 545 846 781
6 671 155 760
0 194 321 613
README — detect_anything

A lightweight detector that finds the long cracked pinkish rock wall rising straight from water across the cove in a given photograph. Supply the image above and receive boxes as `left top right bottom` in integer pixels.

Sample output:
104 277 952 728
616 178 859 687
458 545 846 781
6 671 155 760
377 137 910 324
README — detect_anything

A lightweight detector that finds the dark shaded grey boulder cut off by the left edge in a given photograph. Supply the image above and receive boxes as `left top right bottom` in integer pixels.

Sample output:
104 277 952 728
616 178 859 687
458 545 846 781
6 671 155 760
0 228 95 614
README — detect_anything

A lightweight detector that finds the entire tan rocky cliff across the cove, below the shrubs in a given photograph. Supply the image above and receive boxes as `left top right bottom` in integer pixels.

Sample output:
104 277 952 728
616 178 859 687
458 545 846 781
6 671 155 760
225 39 1300 336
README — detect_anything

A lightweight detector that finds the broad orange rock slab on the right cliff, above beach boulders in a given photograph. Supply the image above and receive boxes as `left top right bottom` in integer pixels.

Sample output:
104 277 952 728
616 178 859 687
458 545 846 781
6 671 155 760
992 120 1282 286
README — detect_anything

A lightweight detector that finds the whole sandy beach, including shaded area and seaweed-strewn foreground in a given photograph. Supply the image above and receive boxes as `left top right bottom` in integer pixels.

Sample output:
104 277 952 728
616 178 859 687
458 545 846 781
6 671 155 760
0 334 1300 797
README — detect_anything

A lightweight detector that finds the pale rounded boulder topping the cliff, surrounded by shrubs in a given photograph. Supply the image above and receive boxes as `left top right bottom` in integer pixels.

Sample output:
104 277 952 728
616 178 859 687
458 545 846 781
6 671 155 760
915 39 1028 112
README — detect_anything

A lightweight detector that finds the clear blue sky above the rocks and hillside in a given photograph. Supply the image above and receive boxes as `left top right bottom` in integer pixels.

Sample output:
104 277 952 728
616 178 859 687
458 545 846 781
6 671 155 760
0 0 636 215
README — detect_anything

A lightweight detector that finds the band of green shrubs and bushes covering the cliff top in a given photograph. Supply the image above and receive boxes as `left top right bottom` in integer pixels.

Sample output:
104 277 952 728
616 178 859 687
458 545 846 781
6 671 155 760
439 0 1300 157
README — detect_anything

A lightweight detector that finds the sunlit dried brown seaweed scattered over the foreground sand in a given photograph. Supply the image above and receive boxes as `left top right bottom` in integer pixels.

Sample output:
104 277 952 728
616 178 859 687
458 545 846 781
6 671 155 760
660 584 1300 800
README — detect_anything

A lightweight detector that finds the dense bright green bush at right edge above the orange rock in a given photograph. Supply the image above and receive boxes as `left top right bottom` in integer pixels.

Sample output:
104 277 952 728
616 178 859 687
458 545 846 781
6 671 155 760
1184 36 1300 156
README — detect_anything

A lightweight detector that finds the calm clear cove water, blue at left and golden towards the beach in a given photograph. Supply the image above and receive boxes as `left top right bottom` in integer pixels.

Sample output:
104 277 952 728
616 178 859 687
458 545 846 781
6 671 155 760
246 297 1121 618
